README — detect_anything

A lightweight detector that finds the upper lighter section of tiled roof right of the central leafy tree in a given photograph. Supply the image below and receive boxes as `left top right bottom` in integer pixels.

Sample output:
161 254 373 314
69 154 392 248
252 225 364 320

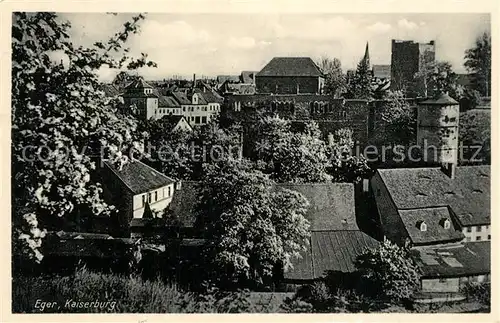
277 183 359 231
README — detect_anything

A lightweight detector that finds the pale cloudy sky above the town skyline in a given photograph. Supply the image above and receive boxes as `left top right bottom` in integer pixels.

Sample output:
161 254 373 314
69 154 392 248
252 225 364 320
60 13 490 81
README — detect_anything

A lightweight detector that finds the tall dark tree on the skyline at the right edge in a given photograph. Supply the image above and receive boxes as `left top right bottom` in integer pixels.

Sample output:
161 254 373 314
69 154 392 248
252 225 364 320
464 32 491 96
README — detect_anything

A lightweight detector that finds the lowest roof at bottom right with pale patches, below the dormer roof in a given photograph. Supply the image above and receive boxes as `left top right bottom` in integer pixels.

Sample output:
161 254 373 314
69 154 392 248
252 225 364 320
411 241 491 277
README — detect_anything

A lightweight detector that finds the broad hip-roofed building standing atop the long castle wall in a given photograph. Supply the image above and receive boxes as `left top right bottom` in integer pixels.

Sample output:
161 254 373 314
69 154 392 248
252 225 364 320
255 57 325 94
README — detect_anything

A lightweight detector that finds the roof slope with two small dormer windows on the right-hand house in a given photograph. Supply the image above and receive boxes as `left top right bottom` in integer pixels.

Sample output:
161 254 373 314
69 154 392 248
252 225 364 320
399 207 464 245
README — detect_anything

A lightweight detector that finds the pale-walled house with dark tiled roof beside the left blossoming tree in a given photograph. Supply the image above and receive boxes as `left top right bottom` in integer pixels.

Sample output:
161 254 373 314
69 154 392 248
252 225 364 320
99 160 180 232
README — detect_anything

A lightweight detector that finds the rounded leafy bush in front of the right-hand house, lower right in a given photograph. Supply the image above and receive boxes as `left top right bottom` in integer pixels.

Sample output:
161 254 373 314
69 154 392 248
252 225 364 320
355 239 420 302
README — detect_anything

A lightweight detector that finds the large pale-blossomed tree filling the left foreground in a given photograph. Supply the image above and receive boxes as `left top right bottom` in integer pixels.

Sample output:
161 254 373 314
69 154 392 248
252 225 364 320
11 12 155 260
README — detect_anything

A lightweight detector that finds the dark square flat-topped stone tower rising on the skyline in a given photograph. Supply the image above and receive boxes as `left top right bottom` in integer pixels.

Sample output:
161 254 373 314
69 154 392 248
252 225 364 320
391 39 436 96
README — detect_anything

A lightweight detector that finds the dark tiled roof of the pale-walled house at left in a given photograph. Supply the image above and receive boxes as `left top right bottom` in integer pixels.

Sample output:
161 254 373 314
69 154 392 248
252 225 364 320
104 160 174 194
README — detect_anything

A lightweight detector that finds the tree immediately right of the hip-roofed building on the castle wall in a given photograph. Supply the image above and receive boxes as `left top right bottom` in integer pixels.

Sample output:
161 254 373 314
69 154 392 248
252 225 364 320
318 57 347 98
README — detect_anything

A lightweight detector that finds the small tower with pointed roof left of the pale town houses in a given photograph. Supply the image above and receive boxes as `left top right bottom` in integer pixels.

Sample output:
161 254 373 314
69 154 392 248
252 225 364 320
123 78 158 119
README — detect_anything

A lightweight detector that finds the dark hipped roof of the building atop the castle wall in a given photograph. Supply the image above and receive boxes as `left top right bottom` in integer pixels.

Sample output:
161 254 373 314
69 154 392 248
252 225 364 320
256 57 323 77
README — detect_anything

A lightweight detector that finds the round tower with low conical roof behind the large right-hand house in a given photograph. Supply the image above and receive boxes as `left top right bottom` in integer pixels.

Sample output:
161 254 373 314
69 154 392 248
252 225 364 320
417 93 460 178
